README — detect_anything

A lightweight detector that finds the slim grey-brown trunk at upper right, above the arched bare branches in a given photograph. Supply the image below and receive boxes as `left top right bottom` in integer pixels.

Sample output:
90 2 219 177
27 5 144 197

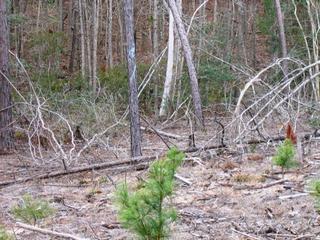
274 0 288 76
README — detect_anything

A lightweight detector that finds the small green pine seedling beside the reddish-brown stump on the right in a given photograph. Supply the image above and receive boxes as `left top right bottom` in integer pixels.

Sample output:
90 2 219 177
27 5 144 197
272 139 298 177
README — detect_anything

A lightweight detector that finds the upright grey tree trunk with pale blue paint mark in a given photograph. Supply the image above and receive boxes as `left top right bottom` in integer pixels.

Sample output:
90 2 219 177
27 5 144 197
123 0 142 157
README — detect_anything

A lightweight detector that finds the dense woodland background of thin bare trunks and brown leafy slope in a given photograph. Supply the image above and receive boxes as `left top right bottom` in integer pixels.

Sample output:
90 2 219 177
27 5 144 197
1 0 319 154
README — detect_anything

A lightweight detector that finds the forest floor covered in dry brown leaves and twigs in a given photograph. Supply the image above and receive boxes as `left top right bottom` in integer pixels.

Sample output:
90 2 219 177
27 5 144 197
0 115 320 240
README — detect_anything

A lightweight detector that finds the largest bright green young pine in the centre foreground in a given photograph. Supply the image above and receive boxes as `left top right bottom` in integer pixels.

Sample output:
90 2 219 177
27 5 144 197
115 149 184 240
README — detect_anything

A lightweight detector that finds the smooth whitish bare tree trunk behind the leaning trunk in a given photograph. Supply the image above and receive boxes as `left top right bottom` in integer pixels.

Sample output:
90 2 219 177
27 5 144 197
159 11 174 118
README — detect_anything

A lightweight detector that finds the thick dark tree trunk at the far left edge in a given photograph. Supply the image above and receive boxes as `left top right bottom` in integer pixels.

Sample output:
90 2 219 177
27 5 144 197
0 0 13 153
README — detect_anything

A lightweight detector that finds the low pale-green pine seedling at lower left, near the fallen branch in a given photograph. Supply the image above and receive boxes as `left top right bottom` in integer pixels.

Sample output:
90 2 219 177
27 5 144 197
11 194 54 225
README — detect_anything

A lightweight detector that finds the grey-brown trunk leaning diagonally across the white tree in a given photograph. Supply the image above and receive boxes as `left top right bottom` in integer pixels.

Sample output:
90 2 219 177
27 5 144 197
167 0 204 126
